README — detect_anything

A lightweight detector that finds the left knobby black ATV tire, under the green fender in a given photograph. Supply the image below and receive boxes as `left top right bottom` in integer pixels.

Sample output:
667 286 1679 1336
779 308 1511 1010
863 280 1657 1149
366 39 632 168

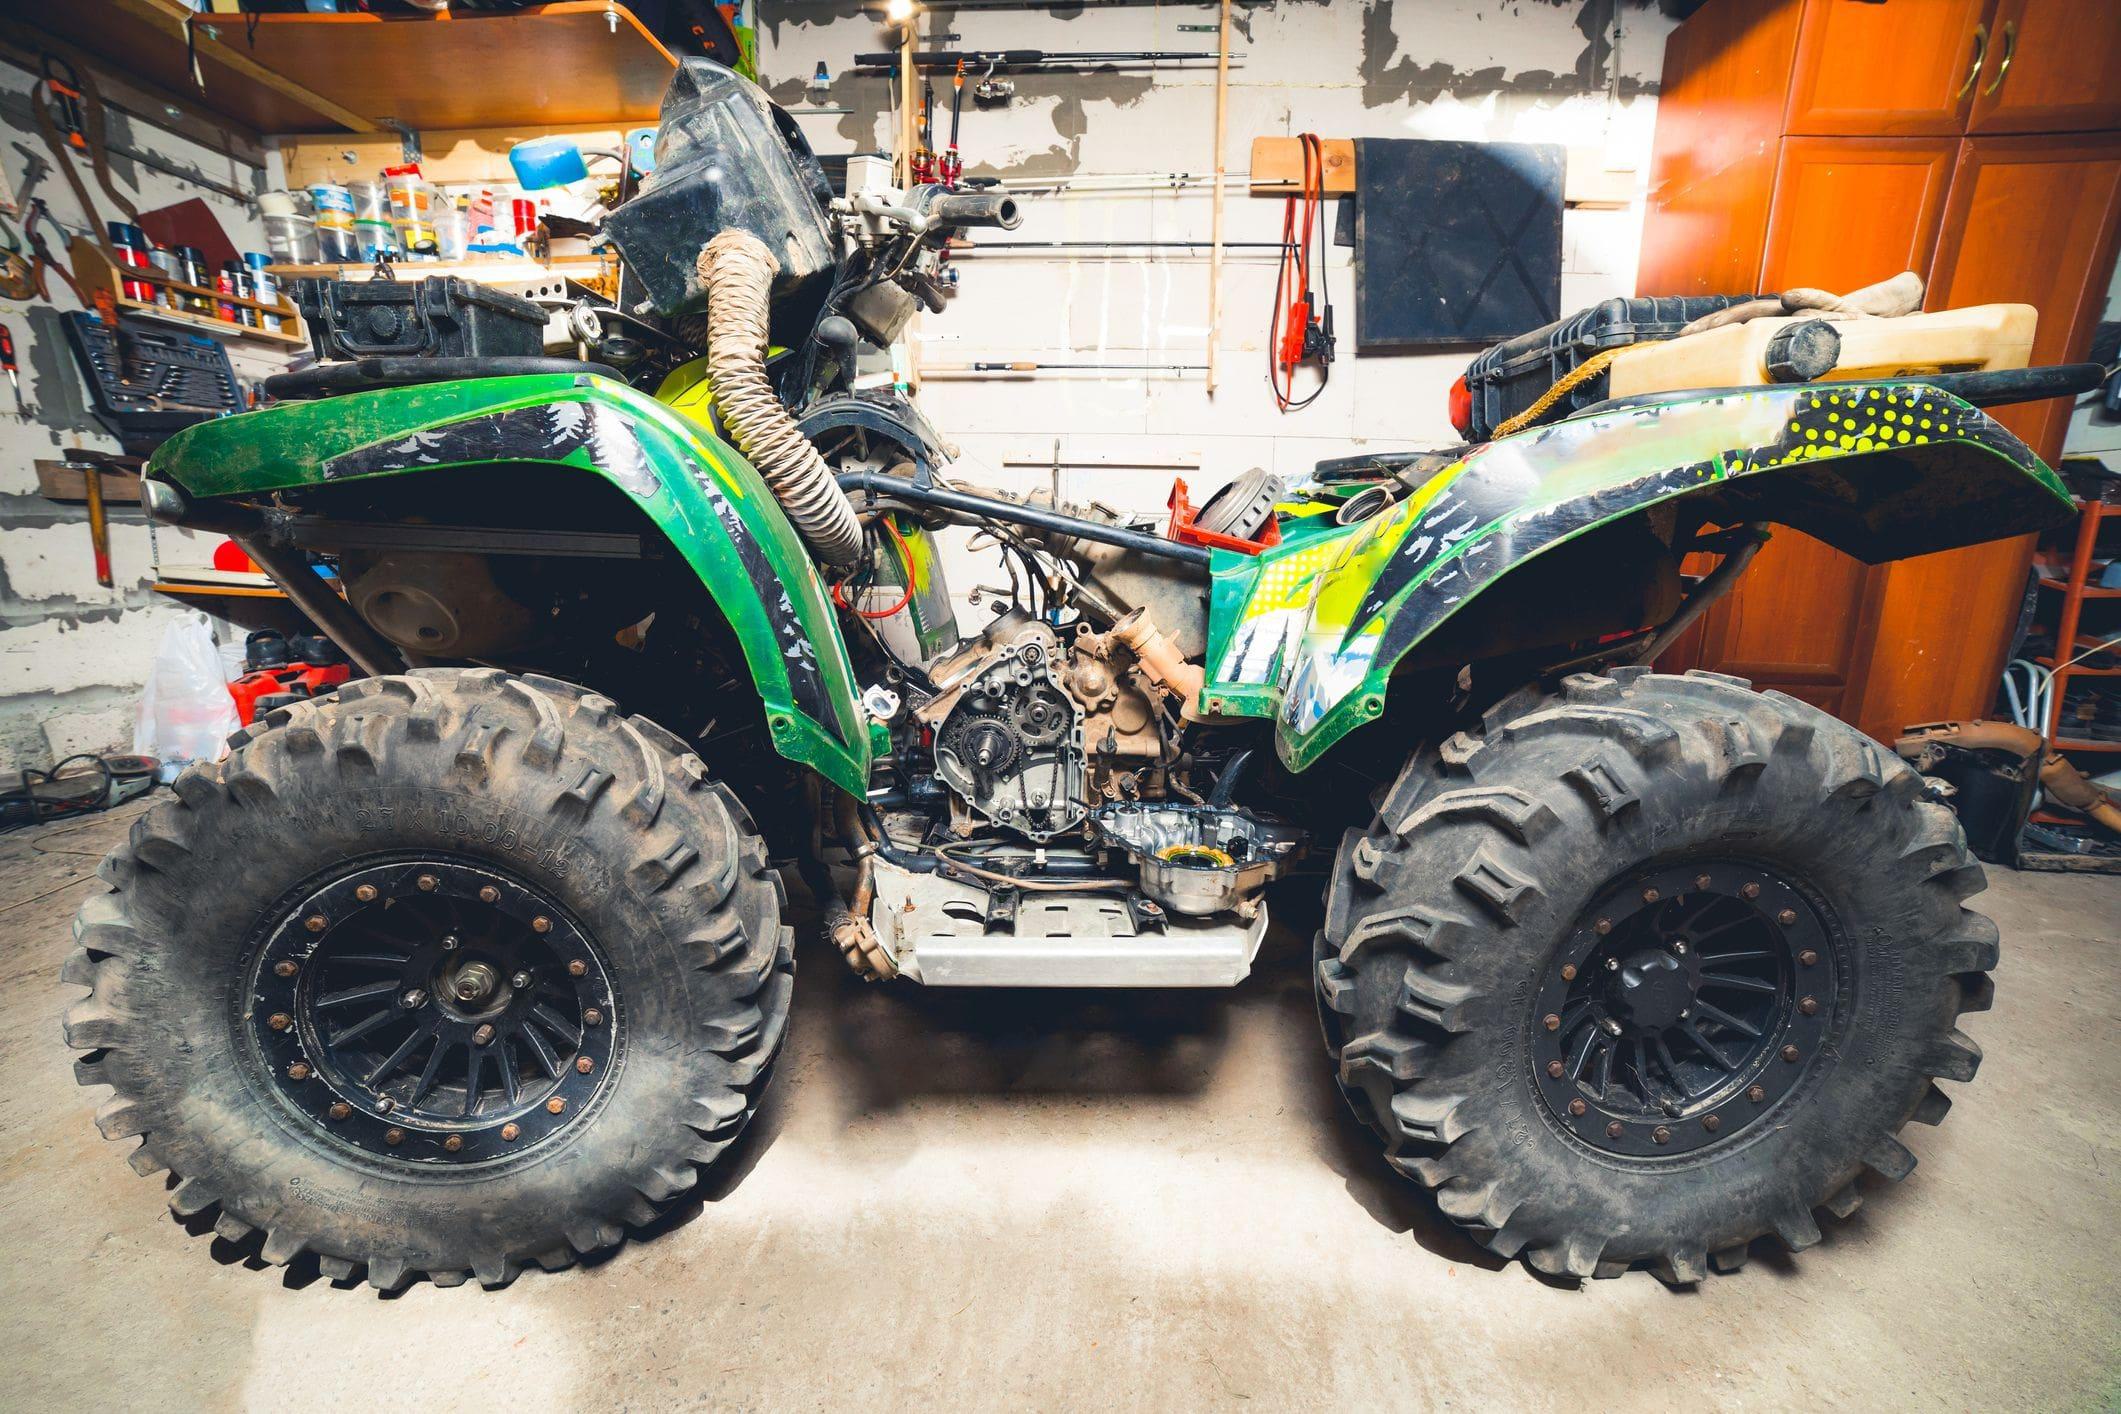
64 668 795 1289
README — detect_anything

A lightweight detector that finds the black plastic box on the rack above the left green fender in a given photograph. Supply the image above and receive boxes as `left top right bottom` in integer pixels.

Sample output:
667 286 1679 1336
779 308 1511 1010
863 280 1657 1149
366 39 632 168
293 276 545 358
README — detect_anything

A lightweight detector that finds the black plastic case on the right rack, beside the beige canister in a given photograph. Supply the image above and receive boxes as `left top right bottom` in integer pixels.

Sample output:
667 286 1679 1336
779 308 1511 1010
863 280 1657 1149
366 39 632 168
1466 295 1758 441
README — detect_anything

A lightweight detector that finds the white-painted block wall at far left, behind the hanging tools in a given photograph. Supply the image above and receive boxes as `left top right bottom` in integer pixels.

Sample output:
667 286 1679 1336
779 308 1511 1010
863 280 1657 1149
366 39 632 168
0 66 280 778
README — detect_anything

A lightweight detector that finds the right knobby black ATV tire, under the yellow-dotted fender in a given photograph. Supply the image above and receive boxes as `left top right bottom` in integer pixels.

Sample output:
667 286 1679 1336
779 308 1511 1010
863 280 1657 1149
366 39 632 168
1315 670 1998 1283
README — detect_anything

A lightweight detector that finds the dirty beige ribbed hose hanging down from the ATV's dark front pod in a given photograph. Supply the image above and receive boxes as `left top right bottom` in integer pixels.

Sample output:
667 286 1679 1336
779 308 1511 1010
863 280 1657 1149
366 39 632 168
698 231 861 570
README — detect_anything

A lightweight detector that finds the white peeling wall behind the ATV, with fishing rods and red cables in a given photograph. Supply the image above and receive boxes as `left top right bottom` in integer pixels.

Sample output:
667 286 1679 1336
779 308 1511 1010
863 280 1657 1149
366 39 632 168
759 0 1671 625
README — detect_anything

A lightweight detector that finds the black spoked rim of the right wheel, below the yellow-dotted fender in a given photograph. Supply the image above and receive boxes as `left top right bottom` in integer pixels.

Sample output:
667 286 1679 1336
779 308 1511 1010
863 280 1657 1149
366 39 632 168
1529 861 1843 1157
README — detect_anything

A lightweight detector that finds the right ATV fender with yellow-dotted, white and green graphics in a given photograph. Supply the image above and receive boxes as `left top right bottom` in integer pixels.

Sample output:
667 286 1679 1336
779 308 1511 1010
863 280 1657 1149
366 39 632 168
1203 382 2072 770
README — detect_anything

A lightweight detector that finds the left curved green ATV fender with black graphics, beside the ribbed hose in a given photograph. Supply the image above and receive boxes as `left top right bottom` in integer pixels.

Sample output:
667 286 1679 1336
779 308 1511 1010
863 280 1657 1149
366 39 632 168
148 373 870 795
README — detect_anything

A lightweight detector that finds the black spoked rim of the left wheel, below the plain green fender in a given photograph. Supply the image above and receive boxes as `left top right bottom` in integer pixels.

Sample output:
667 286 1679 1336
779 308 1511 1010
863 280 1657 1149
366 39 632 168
244 859 624 1168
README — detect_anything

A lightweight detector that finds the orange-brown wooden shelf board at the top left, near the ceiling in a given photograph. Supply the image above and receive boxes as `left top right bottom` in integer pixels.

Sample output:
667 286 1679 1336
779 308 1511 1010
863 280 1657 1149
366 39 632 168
190 0 677 129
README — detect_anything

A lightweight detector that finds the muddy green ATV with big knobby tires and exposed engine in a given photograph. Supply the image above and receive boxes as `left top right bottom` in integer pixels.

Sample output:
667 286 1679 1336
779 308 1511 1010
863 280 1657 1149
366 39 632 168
66 61 2070 1289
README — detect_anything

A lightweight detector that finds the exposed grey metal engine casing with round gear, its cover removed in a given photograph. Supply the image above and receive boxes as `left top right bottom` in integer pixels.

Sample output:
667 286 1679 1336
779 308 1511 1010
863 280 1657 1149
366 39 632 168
935 623 1086 839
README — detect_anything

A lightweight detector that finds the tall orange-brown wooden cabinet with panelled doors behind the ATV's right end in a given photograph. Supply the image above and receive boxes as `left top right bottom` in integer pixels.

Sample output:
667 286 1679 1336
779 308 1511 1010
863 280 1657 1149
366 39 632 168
1637 0 2121 740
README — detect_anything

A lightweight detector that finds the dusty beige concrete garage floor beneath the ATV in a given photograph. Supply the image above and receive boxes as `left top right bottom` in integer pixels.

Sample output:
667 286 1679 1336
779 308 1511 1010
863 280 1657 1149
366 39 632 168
0 808 2121 1410
